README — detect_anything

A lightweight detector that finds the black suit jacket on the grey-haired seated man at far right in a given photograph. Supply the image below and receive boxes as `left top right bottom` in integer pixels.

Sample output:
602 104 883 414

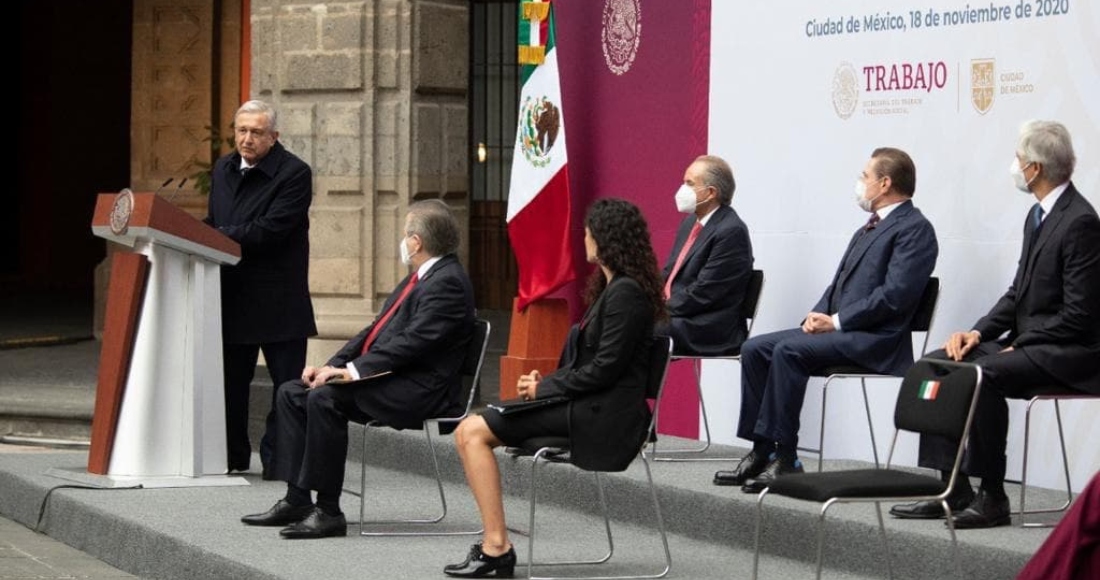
974 184 1100 394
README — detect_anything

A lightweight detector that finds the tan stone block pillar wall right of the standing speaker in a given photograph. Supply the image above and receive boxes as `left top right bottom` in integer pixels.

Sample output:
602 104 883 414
251 0 470 363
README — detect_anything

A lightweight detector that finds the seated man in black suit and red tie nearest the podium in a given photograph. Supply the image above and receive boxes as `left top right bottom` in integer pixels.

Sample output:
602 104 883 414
241 199 474 538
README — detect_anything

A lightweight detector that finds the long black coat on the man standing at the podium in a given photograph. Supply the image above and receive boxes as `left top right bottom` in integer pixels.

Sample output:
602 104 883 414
205 142 317 344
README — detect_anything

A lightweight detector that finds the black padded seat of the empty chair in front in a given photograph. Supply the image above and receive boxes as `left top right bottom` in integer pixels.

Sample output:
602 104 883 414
768 469 946 503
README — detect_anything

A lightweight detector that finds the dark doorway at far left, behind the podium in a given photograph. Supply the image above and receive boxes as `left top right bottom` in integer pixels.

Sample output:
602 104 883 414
0 0 132 338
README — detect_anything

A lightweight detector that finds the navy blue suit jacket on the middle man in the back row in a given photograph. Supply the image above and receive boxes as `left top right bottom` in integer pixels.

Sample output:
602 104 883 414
813 201 939 375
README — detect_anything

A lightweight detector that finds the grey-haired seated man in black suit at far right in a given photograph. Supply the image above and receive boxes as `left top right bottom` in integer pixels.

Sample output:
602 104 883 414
890 121 1100 528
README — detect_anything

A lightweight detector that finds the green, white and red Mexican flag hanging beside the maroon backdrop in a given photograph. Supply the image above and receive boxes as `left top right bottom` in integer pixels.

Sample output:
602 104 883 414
507 0 574 309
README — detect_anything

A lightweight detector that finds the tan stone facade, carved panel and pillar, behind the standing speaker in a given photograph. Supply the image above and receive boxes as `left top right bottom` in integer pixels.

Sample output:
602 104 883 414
121 0 471 361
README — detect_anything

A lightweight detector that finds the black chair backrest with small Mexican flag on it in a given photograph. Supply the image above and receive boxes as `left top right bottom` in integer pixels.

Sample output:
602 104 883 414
894 359 981 440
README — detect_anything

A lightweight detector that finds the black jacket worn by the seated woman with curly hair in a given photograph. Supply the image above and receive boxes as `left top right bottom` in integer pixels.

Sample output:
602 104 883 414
536 276 653 471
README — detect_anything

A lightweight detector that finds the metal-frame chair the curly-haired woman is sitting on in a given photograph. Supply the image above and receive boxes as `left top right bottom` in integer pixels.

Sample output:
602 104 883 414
506 336 672 580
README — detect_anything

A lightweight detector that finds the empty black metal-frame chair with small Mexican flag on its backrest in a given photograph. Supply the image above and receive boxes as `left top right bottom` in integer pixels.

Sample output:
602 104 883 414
752 359 981 580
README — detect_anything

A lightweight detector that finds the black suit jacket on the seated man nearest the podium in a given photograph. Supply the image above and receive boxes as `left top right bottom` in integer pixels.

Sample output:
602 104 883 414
327 254 474 428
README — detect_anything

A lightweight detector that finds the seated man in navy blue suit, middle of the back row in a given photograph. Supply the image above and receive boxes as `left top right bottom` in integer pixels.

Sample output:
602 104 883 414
714 147 939 493
